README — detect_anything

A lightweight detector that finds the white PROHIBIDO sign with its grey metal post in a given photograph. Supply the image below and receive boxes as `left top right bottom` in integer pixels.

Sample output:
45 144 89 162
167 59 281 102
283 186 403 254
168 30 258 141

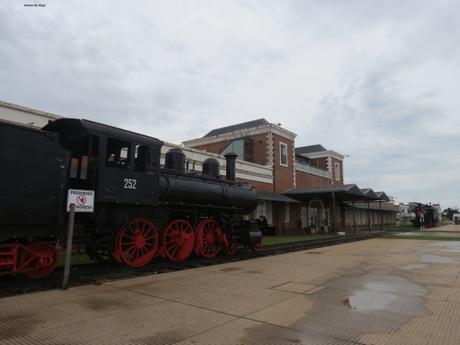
62 189 94 290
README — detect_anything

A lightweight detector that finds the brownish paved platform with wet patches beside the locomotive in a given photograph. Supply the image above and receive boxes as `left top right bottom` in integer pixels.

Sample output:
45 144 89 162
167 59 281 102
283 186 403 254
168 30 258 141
0 239 460 345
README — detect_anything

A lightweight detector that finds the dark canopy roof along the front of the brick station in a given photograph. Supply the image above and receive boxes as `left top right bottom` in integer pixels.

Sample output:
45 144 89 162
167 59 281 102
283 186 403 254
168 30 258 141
284 184 386 202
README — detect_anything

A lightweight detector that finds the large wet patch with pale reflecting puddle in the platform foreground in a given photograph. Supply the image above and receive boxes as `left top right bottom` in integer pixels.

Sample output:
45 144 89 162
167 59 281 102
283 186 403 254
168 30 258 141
241 273 429 344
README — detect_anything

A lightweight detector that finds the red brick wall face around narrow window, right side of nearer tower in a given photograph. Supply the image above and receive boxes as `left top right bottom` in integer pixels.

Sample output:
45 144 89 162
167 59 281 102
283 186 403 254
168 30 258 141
273 134 295 193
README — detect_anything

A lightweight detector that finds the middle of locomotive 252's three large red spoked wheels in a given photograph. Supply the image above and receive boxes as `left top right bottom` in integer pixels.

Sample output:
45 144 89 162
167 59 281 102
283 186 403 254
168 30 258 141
162 219 195 262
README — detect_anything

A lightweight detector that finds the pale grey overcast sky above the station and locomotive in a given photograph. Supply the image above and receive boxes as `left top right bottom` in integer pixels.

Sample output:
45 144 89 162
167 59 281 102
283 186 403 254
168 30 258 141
0 0 460 207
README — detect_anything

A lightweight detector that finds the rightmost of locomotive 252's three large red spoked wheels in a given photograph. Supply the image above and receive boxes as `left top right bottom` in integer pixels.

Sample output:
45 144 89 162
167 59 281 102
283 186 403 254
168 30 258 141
195 219 223 258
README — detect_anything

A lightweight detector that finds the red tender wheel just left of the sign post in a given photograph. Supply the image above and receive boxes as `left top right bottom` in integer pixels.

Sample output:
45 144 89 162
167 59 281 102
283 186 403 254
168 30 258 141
19 242 57 279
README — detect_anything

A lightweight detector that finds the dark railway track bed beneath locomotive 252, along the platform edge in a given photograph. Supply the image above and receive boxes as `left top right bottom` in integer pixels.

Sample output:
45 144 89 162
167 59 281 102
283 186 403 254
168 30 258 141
0 232 385 298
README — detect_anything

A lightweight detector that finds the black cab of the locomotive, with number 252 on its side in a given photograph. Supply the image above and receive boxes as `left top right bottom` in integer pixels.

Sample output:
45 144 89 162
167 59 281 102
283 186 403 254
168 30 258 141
44 119 163 205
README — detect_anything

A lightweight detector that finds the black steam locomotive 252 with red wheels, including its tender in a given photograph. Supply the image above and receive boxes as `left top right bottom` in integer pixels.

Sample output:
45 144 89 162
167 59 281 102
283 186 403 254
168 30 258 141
0 119 261 278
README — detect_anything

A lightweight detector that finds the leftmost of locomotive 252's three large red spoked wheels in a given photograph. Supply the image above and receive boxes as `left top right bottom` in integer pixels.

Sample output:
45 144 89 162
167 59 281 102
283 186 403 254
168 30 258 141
114 218 158 267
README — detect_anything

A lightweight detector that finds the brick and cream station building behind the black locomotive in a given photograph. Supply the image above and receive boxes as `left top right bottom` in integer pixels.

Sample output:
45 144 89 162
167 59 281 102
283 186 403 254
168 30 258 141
0 101 398 235
